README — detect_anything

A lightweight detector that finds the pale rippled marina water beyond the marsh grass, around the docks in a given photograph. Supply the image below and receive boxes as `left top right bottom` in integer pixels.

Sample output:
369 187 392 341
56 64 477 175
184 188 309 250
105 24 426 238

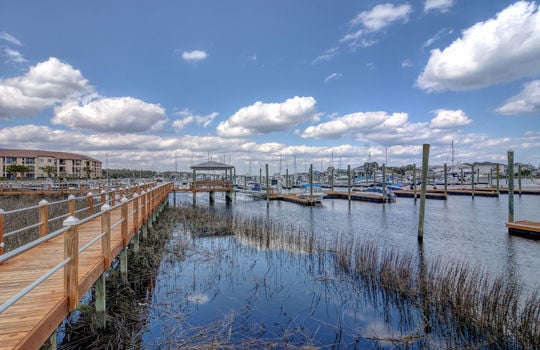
178 191 540 291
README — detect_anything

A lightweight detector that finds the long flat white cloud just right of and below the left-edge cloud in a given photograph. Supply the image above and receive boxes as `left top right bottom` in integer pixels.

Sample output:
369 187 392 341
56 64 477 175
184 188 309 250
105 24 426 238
52 97 167 133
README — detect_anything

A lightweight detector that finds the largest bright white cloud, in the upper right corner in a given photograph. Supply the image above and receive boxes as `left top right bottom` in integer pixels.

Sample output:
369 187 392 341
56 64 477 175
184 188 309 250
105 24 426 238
416 1 540 91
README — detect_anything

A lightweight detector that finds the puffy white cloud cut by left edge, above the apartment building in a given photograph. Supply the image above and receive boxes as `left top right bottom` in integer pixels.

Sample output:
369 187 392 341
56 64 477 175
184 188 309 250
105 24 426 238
0 57 92 119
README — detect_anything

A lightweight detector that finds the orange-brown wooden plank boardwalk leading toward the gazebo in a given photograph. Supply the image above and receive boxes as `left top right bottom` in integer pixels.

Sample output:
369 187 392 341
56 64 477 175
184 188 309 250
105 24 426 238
0 184 171 350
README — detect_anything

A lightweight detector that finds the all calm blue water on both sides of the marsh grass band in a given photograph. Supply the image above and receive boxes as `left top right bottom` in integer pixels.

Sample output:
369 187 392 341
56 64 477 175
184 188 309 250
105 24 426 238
143 194 540 348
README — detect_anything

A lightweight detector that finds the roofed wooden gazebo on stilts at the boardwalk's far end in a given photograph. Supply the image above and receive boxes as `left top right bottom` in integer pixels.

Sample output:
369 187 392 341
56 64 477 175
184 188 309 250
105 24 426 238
189 161 234 203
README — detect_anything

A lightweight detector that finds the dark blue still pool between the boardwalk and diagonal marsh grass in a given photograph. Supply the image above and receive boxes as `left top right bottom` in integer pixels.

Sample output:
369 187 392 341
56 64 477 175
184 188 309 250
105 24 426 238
143 228 416 348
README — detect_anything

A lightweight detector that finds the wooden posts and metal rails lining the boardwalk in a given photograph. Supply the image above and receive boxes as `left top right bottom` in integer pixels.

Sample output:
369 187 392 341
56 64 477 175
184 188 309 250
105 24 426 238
0 183 172 315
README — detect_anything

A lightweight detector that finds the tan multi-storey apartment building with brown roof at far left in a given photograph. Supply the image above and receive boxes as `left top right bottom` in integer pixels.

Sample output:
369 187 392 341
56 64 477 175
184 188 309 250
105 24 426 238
0 148 102 179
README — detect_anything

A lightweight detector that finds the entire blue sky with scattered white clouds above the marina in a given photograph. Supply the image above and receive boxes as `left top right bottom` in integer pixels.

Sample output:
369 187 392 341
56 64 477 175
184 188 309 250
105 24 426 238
0 0 540 174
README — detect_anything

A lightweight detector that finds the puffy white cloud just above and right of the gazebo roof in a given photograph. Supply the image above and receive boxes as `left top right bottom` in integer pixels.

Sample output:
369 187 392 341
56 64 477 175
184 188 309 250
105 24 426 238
217 96 316 137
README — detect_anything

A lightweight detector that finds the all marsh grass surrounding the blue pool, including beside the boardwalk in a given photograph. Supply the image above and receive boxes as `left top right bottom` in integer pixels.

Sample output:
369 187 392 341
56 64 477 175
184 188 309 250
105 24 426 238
57 206 540 349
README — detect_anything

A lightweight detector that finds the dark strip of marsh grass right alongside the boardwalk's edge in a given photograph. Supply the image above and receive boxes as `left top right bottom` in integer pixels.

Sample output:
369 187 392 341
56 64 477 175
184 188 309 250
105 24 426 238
58 211 175 350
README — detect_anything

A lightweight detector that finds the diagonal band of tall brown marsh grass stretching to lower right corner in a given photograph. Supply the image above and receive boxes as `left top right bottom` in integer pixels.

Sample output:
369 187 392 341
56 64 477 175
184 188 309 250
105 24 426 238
170 207 540 349
